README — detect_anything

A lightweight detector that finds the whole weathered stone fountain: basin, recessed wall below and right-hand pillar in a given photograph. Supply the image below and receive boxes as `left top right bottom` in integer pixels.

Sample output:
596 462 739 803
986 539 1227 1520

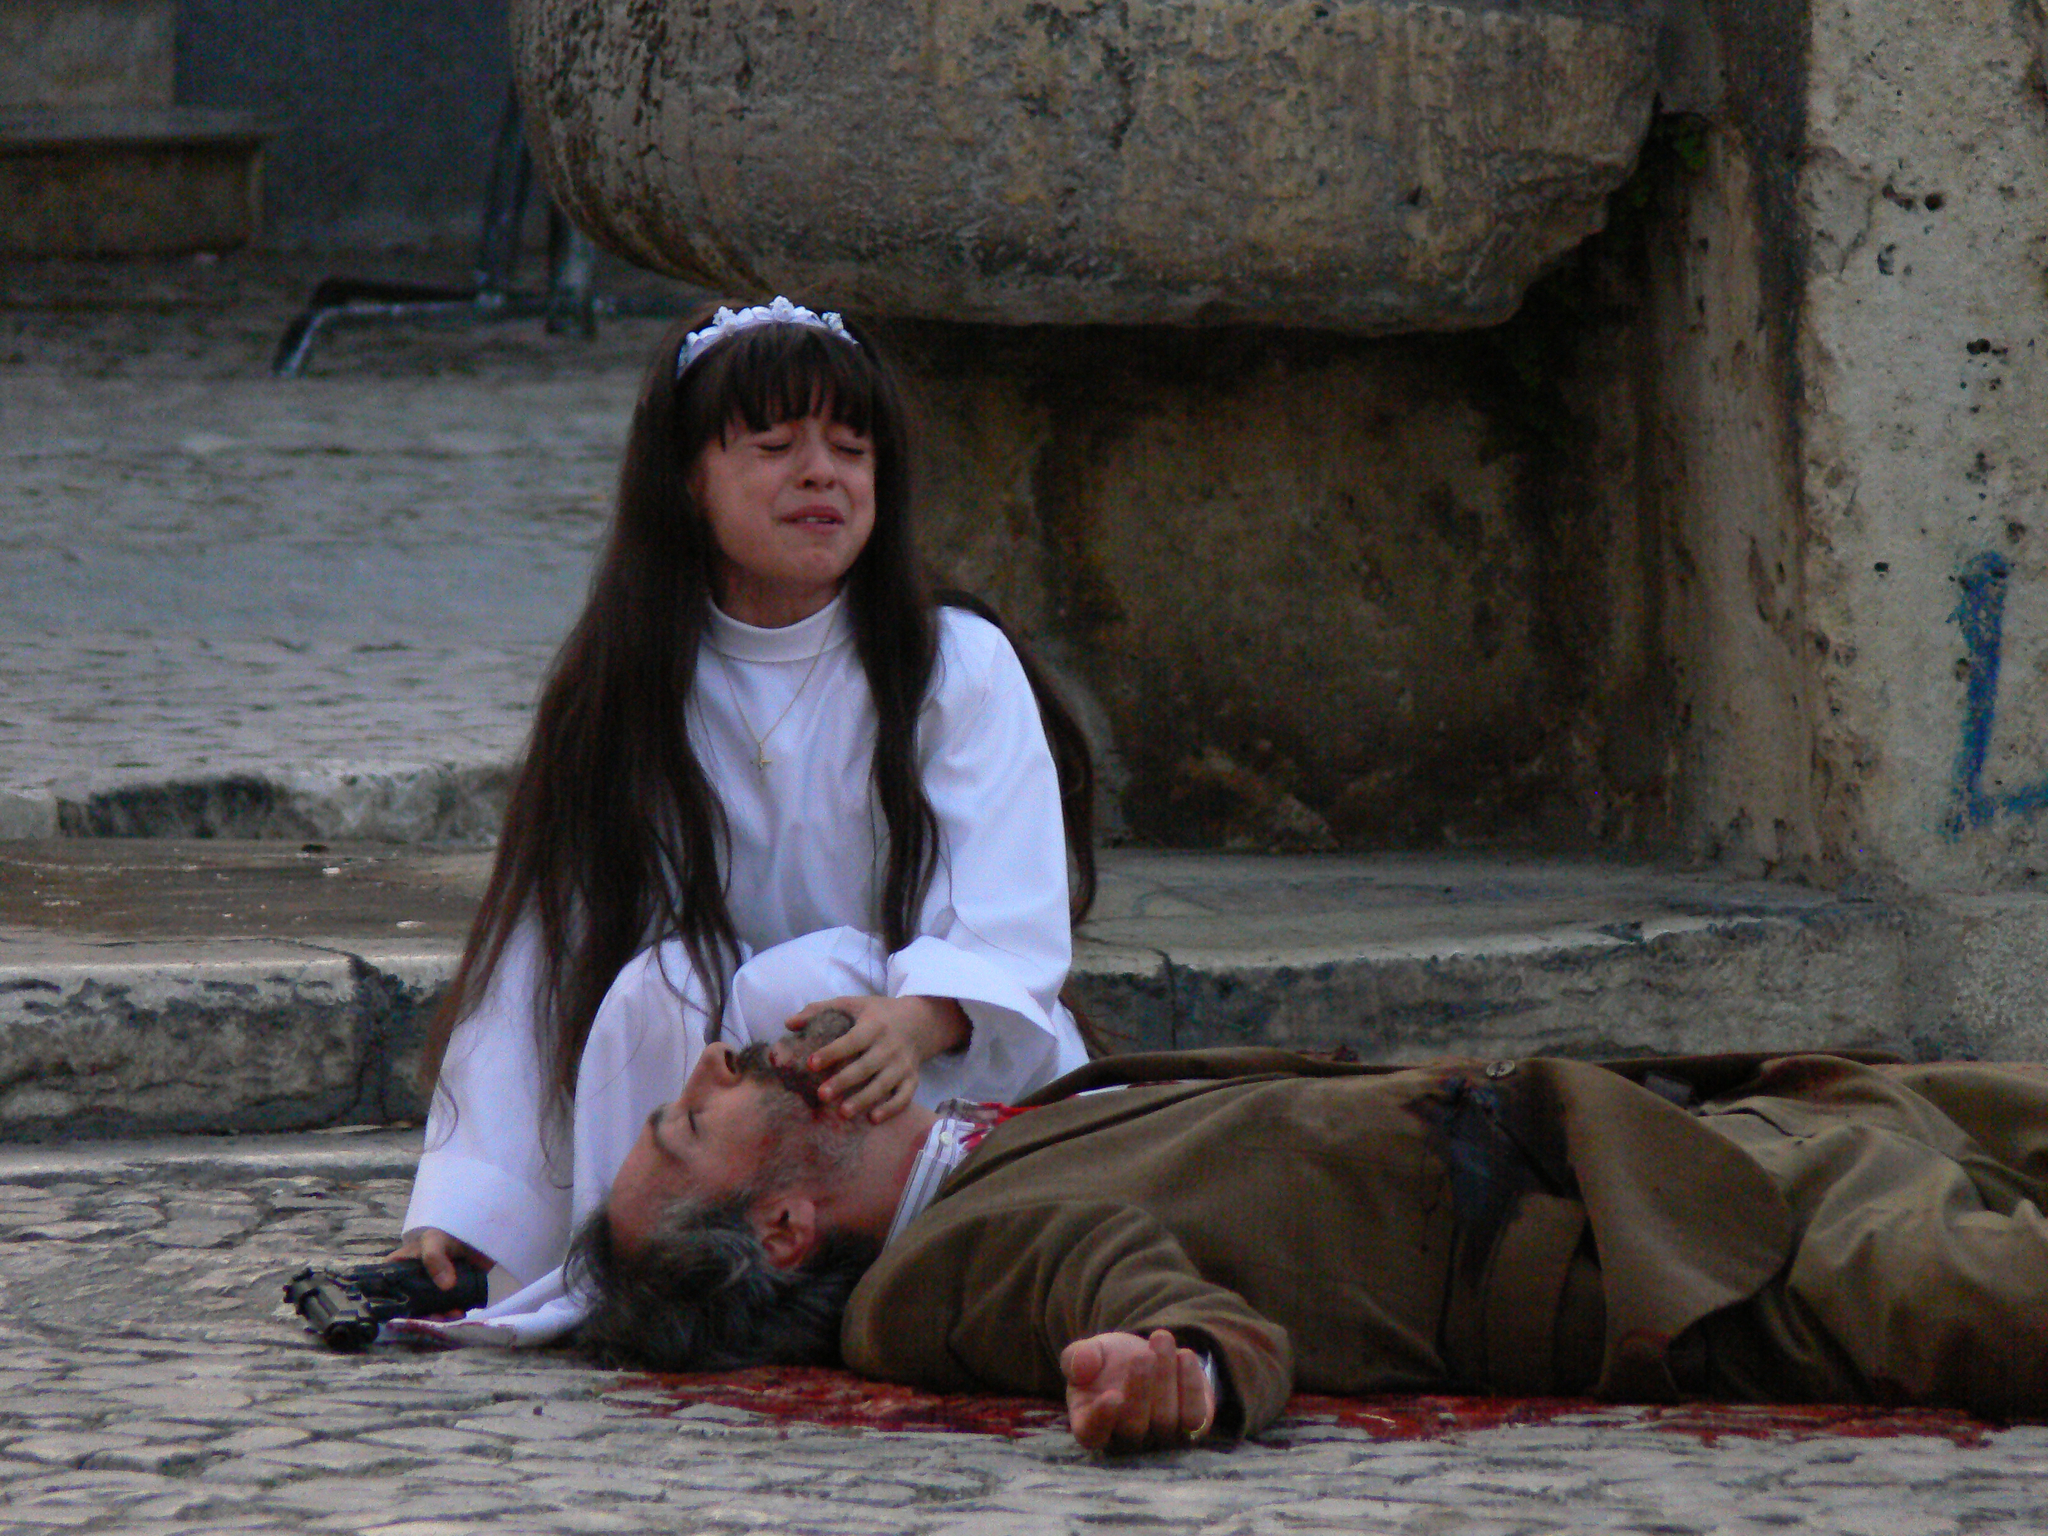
514 0 2048 891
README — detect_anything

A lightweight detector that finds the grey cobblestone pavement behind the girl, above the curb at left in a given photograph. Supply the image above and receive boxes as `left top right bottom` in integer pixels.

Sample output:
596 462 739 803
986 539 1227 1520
0 254 688 831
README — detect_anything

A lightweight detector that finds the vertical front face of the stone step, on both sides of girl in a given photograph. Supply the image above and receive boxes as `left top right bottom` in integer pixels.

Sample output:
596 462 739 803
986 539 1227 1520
0 899 1941 1141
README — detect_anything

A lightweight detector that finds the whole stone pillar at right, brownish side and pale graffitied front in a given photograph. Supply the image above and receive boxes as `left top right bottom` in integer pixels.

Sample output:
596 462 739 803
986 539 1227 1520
1653 0 2048 891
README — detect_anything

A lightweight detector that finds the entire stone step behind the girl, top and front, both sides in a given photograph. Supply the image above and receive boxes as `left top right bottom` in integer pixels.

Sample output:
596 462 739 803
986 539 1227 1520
0 840 2048 1141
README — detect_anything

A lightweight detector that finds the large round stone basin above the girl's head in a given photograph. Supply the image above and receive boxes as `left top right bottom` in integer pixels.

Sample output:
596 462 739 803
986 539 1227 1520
512 0 1659 332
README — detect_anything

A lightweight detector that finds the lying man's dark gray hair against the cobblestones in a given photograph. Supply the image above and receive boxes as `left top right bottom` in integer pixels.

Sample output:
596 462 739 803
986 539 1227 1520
567 1188 881 1370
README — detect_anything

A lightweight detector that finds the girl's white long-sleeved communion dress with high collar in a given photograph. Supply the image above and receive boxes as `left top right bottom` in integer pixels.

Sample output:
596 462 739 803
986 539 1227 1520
385 598 1085 1343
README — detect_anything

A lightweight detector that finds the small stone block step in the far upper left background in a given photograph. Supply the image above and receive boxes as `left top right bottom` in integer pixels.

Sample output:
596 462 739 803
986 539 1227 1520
0 106 264 256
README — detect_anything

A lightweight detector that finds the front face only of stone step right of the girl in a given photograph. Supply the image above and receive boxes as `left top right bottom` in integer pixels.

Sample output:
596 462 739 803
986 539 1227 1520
1073 903 1915 1061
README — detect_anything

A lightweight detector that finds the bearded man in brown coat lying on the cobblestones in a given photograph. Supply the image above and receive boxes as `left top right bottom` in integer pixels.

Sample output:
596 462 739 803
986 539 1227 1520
571 1024 2048 1448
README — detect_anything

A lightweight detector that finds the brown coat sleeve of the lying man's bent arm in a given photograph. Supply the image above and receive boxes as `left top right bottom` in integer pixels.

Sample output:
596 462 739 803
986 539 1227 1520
842 1200 1294 1436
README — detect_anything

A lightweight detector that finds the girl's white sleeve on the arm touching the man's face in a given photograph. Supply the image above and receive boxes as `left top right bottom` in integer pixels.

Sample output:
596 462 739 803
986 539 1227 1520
887 608 1087 1098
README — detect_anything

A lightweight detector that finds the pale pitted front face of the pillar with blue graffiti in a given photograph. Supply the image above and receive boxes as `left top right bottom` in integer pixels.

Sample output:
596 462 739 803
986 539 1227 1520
1800 0 2048 887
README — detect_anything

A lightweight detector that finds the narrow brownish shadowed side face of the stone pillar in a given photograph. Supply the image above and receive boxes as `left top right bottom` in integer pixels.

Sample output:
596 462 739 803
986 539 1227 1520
1636 0 1849 877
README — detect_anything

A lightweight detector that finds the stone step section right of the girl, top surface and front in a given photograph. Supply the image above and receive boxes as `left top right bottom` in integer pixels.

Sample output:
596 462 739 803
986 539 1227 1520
1073 856 1916 1061
